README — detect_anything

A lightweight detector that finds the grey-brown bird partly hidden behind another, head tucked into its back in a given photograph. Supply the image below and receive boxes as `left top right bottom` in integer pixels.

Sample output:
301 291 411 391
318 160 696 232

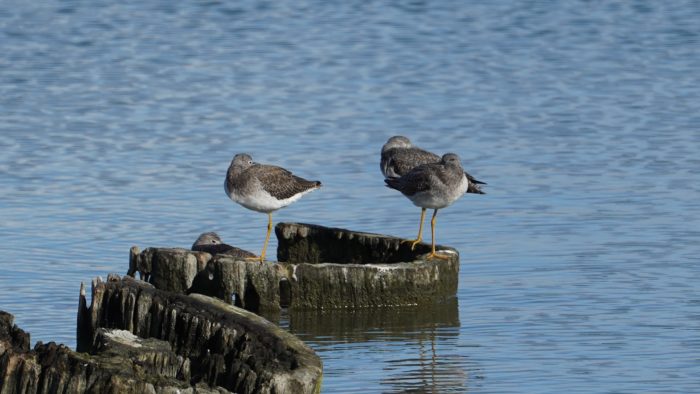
379 135 485 250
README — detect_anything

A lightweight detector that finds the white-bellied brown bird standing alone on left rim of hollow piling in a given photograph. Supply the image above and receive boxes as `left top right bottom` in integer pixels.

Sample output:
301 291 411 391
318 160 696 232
224 153 321 263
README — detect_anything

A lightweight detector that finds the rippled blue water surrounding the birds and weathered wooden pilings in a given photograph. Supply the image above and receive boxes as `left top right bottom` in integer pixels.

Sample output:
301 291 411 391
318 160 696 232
0 0 700 393
